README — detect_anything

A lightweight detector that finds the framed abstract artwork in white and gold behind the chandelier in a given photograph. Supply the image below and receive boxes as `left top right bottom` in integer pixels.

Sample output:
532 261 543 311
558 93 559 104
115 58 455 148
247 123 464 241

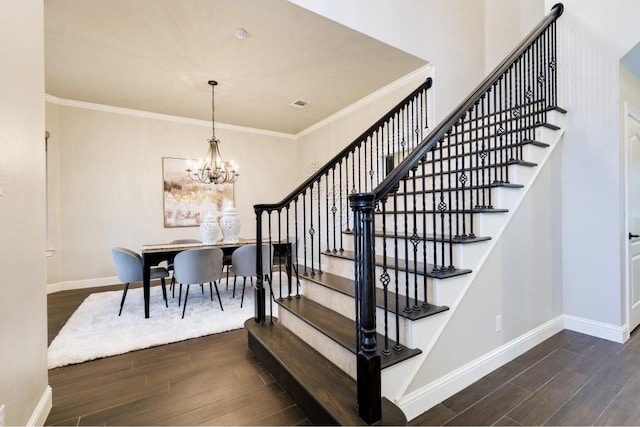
162 157 233 228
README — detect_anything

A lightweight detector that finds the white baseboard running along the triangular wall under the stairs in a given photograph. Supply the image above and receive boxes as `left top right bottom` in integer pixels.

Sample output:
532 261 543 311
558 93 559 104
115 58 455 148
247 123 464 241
396 316 564 420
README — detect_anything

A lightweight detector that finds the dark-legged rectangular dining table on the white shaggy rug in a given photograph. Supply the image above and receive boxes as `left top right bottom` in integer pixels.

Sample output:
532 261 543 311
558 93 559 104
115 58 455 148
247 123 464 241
140 239 292 319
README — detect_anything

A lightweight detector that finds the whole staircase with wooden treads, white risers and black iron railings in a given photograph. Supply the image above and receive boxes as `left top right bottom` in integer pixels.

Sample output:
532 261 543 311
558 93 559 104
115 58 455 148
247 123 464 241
245 5 565 425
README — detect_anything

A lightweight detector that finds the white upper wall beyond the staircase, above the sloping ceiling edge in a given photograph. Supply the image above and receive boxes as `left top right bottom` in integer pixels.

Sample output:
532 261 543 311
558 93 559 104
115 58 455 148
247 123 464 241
290 0 484 125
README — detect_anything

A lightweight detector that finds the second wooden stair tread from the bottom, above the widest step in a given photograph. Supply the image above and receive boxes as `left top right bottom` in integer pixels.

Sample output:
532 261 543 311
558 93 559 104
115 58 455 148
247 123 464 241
276 296 422 369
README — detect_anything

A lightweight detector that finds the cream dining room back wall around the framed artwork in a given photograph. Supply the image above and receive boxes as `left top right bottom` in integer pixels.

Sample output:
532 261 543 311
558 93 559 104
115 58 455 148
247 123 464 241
47 103 296 288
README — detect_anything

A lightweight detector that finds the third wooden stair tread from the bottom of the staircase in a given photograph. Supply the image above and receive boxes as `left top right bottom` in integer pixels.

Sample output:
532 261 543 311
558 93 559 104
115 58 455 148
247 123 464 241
301 271 449 320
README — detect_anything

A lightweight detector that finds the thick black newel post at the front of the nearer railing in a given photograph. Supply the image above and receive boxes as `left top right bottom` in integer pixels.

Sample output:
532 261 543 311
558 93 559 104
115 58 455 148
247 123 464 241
349 193 382 424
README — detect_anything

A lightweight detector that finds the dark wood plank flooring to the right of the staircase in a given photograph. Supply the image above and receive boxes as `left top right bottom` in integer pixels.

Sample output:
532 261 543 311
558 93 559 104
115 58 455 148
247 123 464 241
410 330 640 426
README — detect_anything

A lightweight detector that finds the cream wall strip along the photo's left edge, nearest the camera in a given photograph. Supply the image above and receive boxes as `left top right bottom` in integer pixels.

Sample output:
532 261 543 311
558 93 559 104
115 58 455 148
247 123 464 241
0 0 51 425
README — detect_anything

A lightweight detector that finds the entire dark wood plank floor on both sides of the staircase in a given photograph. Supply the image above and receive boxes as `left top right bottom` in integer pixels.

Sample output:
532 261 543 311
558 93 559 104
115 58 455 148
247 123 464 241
46 287 640 426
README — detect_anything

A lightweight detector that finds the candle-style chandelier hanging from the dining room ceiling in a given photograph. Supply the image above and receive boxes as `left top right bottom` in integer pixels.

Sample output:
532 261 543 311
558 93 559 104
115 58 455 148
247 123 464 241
187 80 240 184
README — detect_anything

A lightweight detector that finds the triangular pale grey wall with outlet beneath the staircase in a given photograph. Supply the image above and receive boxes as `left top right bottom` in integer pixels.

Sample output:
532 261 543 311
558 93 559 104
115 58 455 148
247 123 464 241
407 141 563 393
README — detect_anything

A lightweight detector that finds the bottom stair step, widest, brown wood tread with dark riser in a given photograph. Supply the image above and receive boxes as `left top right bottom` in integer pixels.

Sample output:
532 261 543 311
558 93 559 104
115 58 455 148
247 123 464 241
245 318 407 425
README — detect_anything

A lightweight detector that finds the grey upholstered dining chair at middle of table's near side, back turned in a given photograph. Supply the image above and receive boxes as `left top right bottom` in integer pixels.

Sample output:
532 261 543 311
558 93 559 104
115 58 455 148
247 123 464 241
173 248 224 319
